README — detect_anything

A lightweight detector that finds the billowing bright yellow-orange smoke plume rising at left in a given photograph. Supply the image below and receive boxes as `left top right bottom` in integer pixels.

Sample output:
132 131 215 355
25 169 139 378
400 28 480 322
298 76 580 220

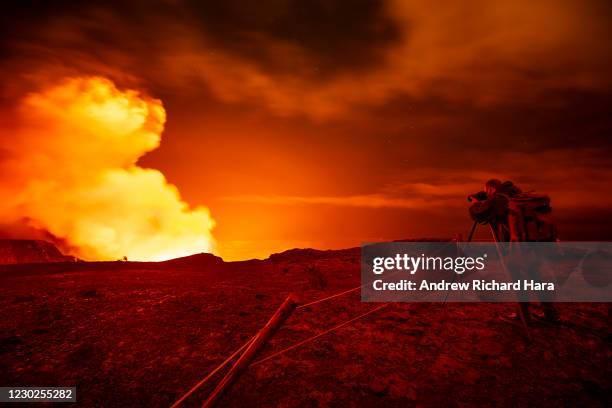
0 77 215 261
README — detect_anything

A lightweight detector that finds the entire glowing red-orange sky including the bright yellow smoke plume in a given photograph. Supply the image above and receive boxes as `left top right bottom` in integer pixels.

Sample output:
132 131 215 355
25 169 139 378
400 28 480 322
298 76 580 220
0 0 612 260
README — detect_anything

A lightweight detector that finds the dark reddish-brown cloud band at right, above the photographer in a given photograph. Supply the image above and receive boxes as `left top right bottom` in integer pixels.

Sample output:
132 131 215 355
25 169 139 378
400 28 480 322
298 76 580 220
362 89 612 155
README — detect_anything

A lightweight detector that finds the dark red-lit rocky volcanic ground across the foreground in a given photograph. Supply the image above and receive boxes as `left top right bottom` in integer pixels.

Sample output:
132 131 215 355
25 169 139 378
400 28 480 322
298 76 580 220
0 248 612 407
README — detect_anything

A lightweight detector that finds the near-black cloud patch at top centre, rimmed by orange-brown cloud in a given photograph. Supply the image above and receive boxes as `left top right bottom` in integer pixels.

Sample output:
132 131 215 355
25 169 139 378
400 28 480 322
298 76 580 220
187 0 406 75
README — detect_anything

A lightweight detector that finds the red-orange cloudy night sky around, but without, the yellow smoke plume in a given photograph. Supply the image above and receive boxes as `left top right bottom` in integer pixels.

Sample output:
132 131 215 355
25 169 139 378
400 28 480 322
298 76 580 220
0 0 612 259
